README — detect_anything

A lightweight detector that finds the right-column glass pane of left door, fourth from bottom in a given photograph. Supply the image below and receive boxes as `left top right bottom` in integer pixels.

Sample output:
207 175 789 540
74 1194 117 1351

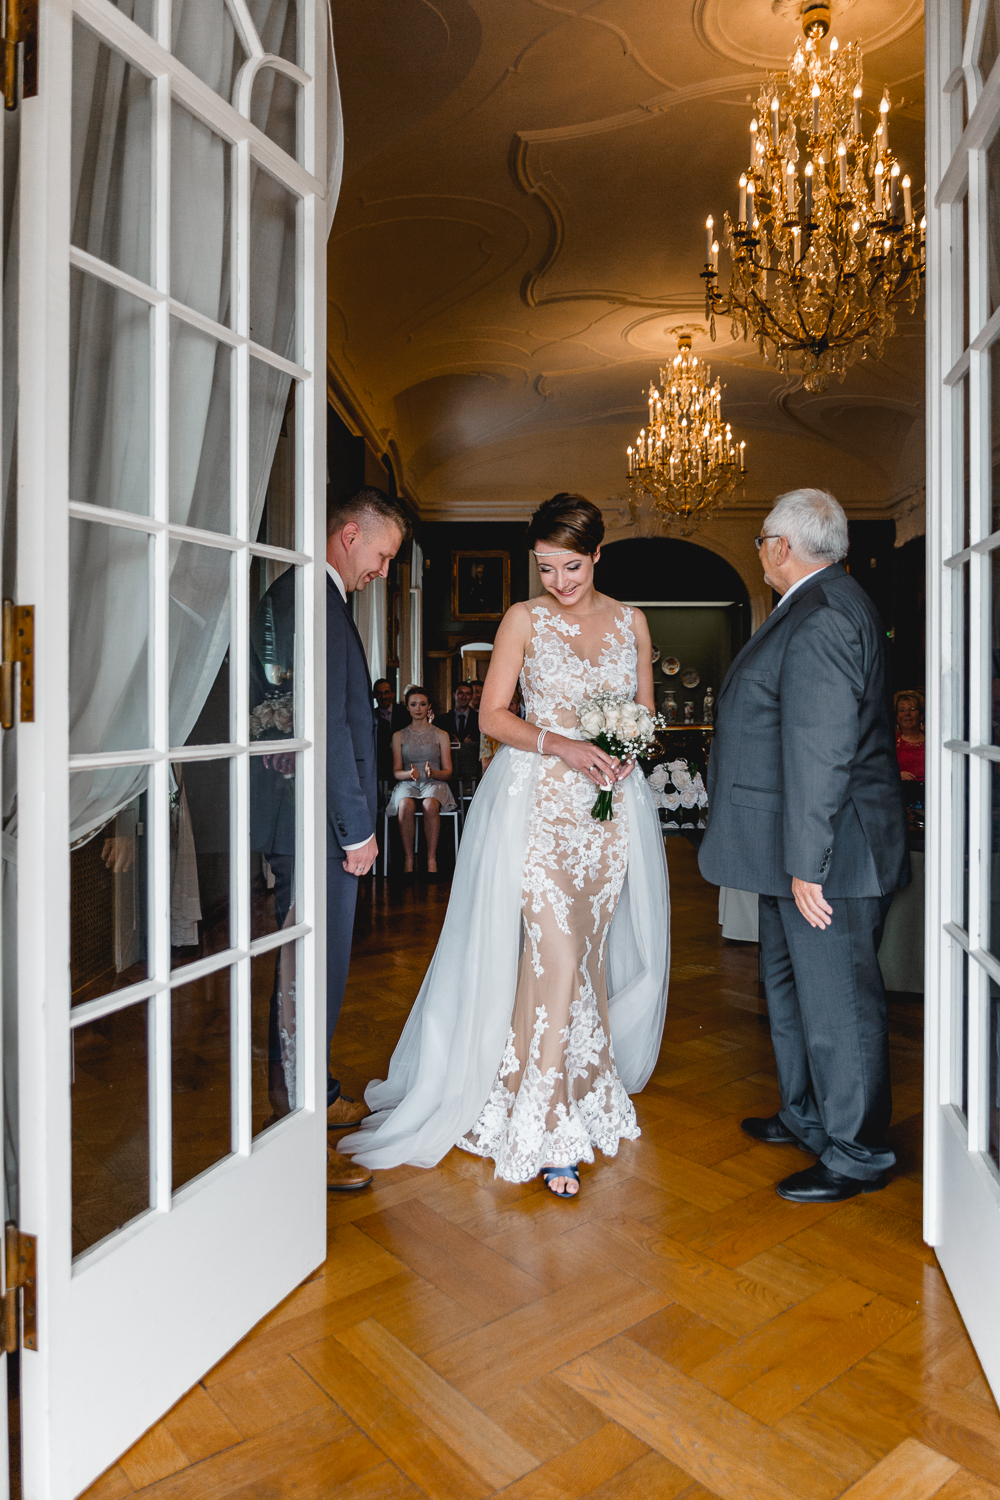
250 369 301 551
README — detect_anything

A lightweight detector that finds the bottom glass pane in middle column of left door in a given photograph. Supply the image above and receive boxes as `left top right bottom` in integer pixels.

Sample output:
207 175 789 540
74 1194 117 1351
169 969 232 1193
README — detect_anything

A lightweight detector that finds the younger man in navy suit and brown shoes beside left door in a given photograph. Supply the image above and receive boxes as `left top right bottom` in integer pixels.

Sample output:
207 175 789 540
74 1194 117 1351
250 488 409 1191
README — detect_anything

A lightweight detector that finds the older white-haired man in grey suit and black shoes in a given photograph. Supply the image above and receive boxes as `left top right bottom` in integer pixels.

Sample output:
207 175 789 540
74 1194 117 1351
699 489 909 1203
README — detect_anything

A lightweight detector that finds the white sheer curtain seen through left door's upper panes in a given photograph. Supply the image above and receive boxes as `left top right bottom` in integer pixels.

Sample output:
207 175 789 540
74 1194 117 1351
60 0 342 843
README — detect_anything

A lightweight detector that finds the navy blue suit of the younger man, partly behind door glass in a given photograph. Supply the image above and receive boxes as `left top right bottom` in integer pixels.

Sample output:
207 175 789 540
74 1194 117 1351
250 569 378 1103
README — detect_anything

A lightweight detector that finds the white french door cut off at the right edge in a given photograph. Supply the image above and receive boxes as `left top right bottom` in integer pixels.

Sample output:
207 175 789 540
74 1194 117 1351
925 0 1000 1395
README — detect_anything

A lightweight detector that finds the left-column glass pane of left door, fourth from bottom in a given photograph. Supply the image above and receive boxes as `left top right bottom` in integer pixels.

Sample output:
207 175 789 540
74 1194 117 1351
69 270 151 516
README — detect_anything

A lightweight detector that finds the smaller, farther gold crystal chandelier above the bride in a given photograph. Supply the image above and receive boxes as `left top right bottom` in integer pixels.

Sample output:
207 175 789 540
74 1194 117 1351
628 333 747 536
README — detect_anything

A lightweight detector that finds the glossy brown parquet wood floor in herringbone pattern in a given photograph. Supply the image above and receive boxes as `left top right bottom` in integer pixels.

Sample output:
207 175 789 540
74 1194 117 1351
80 840 1000 1500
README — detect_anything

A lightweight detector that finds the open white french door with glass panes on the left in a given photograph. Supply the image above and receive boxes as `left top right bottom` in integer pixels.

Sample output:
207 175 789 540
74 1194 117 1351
12 0 328 1500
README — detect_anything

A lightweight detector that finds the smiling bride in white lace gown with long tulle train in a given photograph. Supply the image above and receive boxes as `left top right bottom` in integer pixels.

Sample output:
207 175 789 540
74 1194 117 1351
340 494 669 1197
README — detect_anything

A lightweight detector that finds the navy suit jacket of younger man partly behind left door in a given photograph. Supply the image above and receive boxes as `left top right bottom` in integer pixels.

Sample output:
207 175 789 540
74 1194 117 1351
250 569 378 860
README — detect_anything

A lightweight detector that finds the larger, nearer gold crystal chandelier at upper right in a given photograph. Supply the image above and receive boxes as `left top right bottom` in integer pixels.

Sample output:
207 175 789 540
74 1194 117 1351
702 0 927 392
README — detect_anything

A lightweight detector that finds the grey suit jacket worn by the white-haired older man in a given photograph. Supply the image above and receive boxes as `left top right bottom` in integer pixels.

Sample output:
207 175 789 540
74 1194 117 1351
699 563 909 897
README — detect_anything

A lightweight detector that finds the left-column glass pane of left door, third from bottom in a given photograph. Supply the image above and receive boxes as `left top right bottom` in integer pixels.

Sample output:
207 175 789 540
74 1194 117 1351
69 521 151 755
